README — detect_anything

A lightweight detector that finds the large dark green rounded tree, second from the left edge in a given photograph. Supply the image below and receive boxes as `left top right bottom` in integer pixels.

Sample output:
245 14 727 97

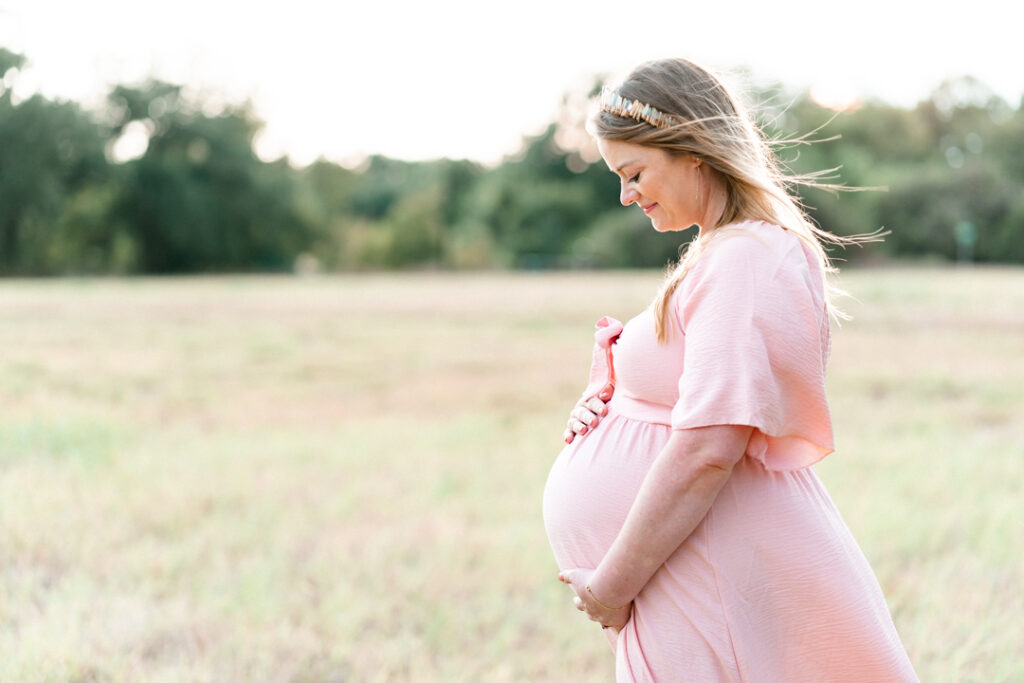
111 82 313 272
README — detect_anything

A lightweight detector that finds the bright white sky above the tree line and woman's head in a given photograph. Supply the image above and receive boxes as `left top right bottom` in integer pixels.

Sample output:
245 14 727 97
0 0 1024 164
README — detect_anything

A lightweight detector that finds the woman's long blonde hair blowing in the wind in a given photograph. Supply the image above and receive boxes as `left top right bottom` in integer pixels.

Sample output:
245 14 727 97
591 58 881 343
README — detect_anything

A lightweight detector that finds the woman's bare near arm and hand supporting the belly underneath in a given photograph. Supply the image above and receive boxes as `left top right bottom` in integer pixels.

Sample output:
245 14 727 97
559 425 754 628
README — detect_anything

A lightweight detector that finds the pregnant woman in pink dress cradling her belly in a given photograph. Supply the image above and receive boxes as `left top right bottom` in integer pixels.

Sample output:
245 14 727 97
544 59 918 683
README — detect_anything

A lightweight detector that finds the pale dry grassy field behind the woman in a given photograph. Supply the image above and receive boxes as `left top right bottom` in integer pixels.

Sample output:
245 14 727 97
0 268 1024 683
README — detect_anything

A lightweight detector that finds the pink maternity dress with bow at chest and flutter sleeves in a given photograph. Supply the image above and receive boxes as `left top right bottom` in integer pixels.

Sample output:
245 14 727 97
544 222 918 683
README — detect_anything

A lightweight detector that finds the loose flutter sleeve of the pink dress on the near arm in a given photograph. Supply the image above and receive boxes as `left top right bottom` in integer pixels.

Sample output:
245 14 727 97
672 236 833 470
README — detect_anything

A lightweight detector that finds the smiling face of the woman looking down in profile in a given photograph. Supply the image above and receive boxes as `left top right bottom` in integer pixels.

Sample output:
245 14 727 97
597 138 703 232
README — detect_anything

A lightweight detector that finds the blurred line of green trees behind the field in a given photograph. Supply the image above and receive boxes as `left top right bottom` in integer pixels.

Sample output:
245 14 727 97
0 48 1024 274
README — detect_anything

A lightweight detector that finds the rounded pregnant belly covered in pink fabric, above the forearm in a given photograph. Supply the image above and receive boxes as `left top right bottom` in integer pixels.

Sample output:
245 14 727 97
544 415 671 569
